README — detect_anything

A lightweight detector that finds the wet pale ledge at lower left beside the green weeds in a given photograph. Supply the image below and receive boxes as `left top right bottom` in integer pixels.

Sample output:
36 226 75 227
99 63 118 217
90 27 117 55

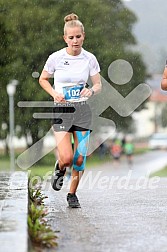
0 172 28 252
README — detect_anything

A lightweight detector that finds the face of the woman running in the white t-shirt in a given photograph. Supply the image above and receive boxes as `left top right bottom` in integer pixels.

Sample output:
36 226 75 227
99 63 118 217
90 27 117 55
64 26 85 55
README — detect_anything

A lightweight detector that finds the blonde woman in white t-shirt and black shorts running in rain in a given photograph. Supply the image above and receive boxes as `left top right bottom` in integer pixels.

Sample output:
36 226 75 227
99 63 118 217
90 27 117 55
39 13 101 208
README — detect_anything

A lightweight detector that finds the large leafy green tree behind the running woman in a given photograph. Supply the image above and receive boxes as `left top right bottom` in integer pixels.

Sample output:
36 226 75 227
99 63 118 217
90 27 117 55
0 0 146 152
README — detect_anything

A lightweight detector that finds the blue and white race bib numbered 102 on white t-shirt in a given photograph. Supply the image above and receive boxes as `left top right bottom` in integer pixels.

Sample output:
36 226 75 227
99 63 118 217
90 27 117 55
63 84 84 101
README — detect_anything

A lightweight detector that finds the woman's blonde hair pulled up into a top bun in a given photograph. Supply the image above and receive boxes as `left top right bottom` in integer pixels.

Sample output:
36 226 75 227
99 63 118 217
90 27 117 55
64 13 84 34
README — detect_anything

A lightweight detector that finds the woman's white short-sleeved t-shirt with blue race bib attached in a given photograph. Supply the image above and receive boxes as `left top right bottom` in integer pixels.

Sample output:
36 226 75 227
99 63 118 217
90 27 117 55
44 48 100 102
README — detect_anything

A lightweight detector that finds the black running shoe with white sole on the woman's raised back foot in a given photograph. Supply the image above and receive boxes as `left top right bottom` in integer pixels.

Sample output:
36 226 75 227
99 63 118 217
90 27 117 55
51 161 66 191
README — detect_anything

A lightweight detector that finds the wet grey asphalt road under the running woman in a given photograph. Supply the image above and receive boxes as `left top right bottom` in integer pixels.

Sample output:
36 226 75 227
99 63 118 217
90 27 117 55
43 151 167 252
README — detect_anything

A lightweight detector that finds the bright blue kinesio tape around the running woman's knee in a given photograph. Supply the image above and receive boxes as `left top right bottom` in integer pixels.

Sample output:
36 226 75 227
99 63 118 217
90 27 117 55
73 131 90 171
